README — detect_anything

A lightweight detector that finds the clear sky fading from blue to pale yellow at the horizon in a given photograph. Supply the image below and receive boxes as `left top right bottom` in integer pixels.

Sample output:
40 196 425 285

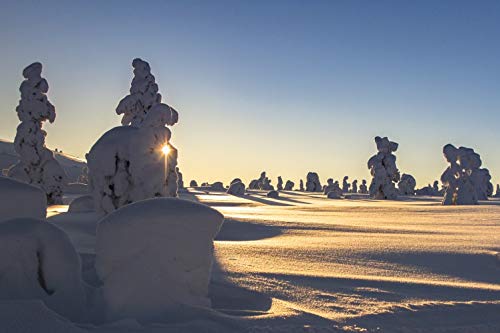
0 0 500 186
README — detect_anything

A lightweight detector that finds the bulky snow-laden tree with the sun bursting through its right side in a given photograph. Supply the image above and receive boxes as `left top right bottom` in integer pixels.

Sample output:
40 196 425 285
87 59 178 213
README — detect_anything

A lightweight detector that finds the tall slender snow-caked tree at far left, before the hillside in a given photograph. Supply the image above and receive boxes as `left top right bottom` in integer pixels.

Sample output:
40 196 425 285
8 62 66 205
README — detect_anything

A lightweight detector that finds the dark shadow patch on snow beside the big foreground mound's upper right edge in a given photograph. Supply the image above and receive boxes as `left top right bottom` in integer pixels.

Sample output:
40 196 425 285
215 218 283 241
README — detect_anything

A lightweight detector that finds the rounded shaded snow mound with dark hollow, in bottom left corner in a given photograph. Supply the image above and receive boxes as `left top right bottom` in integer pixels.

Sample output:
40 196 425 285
0 218 86 321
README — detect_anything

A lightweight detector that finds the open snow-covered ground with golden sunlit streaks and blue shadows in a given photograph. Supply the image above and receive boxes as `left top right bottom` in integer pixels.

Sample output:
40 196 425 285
5 190 500 332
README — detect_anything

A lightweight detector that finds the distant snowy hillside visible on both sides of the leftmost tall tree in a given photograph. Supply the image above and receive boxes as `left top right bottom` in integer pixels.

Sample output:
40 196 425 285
0 139 87 183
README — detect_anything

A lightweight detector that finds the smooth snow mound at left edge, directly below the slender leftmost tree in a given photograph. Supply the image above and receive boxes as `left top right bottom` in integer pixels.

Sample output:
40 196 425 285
0 176 47 221
